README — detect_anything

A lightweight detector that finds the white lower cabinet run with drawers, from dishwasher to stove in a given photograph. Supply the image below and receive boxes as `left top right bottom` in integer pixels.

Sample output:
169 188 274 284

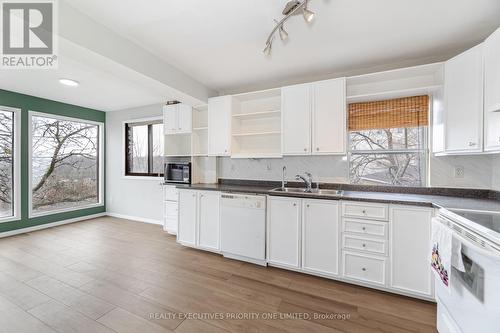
267 196 434 300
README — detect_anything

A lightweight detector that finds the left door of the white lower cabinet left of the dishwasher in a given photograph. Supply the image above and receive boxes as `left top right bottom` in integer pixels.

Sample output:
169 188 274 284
177 190 198 247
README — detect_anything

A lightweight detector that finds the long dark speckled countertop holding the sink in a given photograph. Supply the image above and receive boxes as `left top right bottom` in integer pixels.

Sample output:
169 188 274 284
171 180 500 212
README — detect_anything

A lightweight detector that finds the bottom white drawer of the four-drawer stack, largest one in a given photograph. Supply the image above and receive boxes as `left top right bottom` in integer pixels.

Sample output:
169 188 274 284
343 252 386 285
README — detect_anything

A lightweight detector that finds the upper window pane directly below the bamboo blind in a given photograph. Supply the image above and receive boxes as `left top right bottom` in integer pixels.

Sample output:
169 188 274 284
349 127 425 151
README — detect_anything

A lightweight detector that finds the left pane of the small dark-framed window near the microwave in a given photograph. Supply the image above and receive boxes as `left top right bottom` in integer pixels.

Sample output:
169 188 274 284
127 125 149 173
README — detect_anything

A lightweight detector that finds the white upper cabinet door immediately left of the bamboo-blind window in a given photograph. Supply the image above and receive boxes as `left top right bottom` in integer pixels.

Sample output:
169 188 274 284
312 78 346 154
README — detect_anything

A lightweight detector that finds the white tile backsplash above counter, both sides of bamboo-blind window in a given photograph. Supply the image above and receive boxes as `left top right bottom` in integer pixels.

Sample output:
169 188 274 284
217 155 500 190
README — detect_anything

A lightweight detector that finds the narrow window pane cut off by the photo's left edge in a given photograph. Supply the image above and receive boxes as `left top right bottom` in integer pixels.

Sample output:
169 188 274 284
0 111 14 218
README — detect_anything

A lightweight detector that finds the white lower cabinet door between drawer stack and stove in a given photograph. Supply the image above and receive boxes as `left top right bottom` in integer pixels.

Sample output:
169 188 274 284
389 206 433 297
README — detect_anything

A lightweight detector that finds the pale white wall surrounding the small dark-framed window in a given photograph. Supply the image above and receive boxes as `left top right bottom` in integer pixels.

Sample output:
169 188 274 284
106 105 163 224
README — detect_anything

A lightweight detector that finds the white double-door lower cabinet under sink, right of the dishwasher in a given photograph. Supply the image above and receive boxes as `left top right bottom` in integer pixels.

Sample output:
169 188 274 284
267 197 340 276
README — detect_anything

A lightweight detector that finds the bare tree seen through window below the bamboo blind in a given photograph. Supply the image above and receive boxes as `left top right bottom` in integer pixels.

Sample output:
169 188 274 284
349 127 427 186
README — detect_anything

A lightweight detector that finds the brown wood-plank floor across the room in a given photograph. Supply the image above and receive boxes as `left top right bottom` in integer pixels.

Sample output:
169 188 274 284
0 217 436 333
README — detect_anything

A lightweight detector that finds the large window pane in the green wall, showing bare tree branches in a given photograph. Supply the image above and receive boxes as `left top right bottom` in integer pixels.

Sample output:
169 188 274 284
31 116 99 212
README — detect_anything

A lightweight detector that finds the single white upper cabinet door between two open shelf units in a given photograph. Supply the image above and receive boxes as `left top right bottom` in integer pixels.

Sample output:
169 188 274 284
208 96 233 156
